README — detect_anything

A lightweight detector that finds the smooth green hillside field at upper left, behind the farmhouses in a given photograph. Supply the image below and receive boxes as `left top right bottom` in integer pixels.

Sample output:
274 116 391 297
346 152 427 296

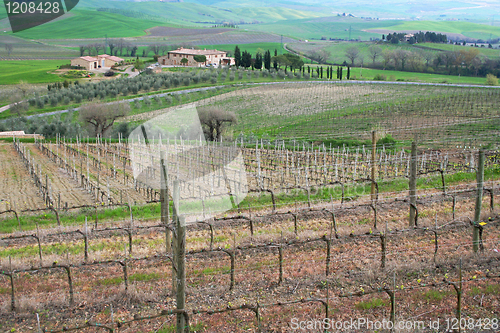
10 10 165 39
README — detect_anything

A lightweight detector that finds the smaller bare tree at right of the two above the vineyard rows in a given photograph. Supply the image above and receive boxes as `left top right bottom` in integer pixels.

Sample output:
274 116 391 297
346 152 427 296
198 107 236 141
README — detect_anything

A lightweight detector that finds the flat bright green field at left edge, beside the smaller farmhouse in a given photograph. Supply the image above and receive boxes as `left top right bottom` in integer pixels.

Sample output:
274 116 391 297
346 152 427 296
0 60 68 84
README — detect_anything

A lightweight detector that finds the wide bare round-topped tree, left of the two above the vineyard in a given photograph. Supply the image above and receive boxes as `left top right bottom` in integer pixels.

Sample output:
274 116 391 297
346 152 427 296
79 103 130 136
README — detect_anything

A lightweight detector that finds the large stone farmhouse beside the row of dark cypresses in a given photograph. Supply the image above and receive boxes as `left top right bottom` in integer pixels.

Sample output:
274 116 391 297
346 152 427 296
158 48 235 67
